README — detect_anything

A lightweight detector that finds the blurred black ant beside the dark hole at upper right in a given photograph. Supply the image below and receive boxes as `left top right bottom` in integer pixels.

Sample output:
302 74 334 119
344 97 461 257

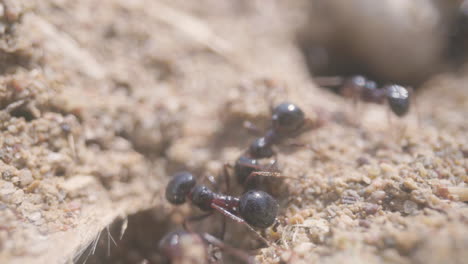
317 75 412 117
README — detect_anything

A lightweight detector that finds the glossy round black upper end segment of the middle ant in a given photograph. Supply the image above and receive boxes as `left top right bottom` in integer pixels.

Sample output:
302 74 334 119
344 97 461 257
272 103 305 135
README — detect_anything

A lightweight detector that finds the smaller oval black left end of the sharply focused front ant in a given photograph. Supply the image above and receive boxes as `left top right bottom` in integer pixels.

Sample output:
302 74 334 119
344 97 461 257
166 171 196 204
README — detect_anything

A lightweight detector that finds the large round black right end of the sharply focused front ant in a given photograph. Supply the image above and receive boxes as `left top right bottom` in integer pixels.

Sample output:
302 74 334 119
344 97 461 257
239 190 279 228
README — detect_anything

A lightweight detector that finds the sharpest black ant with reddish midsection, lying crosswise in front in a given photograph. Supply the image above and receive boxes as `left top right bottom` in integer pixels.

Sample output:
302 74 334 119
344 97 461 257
166 171 279 245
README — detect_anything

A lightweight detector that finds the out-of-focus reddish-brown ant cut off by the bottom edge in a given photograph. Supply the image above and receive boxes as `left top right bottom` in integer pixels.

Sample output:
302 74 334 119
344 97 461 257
158 230 255 264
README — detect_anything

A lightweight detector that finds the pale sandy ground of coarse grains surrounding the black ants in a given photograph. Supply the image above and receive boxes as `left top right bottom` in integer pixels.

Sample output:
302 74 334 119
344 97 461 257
0 0 468 264
